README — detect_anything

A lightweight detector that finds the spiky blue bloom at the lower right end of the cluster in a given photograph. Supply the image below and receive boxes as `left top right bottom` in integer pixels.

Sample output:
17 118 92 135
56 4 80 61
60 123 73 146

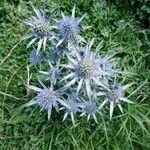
97 83 133 119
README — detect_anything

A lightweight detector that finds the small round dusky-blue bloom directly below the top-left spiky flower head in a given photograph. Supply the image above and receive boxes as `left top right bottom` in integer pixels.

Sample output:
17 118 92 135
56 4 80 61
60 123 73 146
29 50 44 65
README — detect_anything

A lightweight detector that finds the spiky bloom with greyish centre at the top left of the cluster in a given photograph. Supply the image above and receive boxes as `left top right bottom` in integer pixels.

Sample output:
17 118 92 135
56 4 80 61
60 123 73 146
24 4 55 54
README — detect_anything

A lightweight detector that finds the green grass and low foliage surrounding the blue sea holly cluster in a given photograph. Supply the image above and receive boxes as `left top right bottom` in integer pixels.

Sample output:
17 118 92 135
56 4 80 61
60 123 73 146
0 0 150 150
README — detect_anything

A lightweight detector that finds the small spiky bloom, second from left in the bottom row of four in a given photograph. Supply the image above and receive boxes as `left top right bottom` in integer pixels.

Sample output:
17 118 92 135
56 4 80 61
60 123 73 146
60 95 81 125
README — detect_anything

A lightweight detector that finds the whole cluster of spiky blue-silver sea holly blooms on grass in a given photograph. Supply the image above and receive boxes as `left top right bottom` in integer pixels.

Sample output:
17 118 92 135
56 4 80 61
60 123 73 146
25 4 133 124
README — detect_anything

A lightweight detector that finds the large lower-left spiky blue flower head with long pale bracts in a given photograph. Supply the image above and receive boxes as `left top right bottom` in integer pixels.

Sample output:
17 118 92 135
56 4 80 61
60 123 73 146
25 81 64 119
